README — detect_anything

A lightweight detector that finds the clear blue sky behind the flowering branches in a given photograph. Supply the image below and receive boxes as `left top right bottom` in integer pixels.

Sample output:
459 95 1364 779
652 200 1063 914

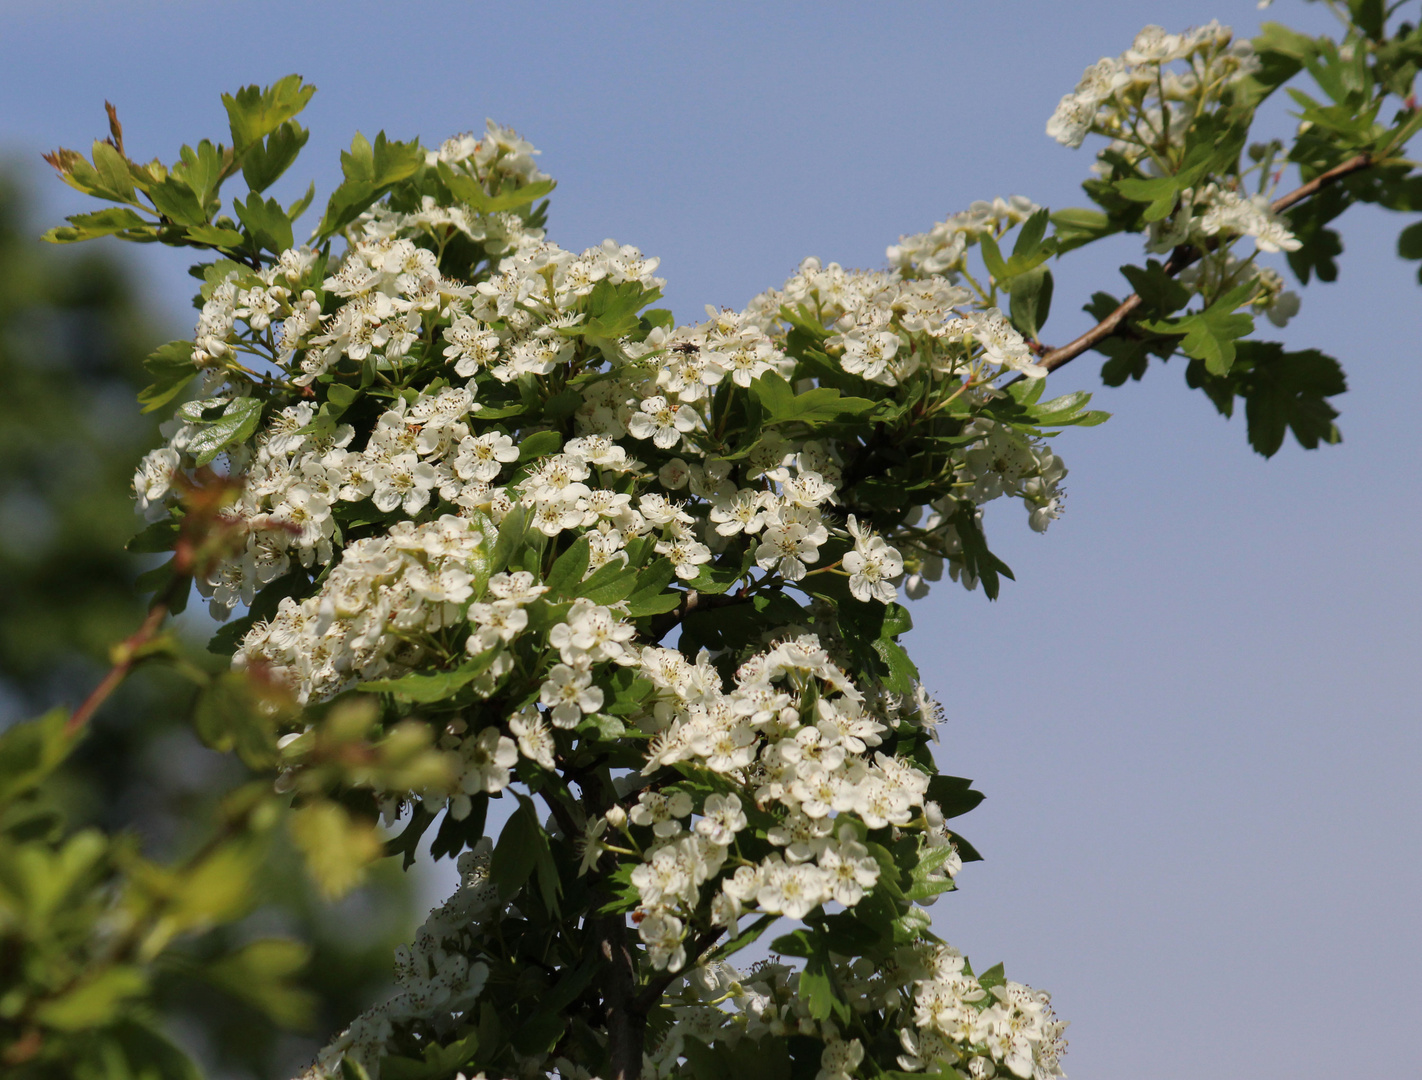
0 0 1422 1080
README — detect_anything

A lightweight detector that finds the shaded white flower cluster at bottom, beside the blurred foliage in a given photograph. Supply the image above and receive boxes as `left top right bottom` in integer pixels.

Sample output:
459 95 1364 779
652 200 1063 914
297 838 499 1080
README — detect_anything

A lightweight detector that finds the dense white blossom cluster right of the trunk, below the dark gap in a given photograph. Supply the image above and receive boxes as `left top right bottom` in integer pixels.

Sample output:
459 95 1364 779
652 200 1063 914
584 635 931 970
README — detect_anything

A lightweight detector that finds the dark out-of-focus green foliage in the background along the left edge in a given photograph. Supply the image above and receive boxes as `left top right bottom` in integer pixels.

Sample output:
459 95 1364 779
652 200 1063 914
0 169 412 1080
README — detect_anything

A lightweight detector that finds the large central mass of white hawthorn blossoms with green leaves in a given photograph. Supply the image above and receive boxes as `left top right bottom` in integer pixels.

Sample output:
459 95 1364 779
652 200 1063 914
127 105 1075 1080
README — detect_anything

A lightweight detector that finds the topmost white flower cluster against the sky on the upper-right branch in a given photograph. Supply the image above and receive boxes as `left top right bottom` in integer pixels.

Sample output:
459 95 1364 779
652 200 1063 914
1047 21 1258 157
